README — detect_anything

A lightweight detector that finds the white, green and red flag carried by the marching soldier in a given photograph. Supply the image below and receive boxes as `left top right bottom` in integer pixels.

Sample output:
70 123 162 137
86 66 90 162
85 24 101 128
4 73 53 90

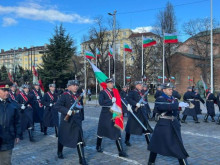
88 60 124 130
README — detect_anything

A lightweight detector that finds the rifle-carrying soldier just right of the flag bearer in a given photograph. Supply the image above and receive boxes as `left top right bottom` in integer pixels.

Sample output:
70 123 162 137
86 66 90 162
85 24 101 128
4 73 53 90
125 81 153 146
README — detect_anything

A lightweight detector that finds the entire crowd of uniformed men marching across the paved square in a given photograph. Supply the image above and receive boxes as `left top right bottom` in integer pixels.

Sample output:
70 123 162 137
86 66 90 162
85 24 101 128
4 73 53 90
0 78 220 165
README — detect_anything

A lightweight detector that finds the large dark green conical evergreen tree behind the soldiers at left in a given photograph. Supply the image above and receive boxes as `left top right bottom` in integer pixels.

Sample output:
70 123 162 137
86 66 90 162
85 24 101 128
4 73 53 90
39 24 76 88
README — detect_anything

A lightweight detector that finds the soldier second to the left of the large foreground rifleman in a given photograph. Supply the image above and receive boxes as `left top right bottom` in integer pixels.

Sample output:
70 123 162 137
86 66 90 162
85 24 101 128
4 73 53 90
30 83 44 132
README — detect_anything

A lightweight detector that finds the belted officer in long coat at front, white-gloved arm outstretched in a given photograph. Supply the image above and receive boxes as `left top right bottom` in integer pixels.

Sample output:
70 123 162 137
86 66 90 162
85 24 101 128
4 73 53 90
148 83 189 165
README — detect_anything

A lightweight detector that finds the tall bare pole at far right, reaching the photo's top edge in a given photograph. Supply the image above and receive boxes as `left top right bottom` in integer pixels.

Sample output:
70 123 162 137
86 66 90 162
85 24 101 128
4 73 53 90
210 0 214 93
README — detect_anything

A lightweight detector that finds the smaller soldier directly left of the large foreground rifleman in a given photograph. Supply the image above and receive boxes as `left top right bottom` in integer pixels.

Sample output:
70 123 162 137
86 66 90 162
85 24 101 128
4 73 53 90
41 84 59 137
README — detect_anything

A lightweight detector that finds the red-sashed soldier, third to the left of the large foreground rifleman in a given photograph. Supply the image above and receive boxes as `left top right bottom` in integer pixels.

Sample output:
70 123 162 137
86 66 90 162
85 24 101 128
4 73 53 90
16 84 35 142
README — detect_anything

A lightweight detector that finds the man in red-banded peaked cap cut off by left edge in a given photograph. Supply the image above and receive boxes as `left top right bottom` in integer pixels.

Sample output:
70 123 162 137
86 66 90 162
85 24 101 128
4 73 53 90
0 82 21 165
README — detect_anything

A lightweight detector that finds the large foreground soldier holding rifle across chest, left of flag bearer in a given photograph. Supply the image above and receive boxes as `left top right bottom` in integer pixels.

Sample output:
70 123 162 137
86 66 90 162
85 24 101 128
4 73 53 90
54 80 87 165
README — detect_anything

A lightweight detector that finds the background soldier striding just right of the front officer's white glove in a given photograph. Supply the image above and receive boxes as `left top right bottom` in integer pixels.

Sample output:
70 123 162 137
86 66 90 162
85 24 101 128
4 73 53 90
181 86 199 123
